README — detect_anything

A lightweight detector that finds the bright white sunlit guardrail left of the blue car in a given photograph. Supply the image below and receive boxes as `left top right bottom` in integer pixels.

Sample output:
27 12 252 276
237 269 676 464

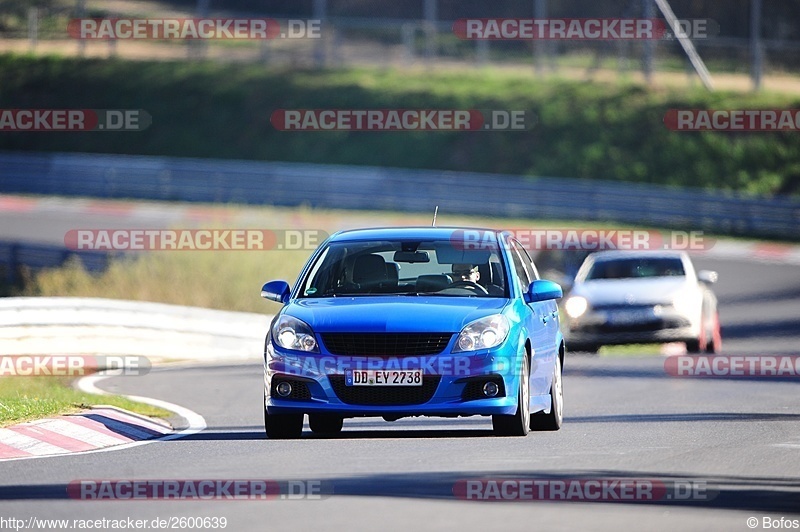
0 297 272 361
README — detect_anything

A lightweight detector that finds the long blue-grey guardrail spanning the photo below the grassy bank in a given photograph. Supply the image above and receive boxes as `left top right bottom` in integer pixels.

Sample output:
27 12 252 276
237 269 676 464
0 152 800 240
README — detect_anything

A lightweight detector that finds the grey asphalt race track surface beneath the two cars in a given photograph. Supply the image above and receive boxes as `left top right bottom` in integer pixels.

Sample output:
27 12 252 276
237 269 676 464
0 205 800 530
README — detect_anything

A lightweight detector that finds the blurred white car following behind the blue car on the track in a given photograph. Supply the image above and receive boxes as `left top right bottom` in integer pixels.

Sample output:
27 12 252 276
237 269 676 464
564 251 722 353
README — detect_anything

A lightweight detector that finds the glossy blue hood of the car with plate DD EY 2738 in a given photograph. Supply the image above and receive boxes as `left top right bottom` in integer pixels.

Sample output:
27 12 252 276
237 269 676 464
284 296 508 333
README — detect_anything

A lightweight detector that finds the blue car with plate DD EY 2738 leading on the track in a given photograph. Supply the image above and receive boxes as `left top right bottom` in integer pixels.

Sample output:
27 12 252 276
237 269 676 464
261 227 565 439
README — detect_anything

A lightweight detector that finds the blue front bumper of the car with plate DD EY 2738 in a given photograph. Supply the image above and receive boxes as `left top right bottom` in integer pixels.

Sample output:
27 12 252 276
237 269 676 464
264 342 521 418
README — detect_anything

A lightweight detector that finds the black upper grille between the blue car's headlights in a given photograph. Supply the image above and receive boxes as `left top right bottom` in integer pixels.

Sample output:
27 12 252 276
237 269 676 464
321 333 453 356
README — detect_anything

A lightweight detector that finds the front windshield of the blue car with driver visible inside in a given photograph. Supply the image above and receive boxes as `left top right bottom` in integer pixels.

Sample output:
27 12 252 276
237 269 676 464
299 240 508 298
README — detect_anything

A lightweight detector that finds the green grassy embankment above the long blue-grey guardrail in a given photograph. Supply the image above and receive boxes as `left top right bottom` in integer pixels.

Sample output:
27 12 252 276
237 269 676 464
0 54 800 194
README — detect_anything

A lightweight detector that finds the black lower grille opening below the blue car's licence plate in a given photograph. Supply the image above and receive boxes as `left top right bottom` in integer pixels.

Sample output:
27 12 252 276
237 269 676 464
328 375 441 406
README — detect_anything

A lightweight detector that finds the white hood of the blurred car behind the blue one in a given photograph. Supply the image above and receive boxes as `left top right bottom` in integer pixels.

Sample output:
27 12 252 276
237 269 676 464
570 277 692 306
